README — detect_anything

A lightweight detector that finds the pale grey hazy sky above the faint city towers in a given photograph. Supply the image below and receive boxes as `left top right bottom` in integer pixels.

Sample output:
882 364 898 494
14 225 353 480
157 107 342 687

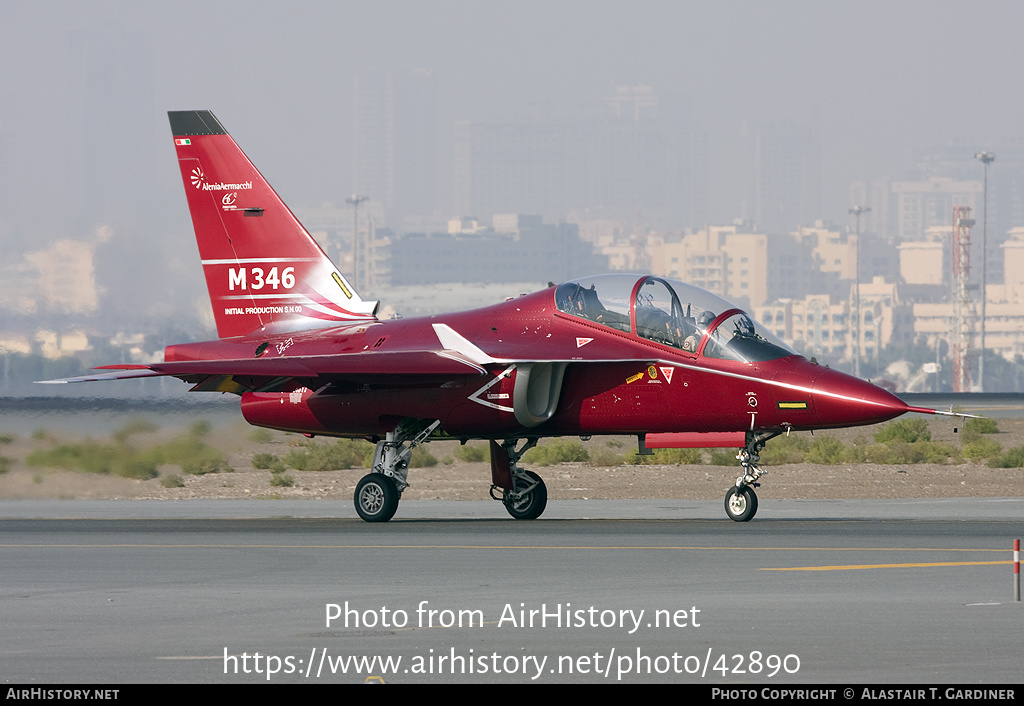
0 0 1024 237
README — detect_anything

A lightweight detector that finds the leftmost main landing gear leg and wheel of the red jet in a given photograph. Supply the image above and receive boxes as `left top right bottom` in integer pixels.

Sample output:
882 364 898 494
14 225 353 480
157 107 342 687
354 419 440 523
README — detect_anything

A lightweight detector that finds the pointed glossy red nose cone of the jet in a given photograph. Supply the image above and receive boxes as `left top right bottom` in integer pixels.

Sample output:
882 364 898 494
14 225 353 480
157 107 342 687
814 369 910 426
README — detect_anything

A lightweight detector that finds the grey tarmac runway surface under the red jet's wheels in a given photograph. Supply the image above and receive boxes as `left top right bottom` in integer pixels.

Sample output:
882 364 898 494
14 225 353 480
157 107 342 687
0 498 1024 686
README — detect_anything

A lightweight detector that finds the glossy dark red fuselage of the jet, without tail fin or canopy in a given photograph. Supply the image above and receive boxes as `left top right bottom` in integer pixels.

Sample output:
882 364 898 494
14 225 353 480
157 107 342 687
157 288 910 439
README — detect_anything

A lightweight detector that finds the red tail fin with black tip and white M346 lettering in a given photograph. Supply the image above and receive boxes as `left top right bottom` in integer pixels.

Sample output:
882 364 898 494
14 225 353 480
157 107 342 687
168 111 378 338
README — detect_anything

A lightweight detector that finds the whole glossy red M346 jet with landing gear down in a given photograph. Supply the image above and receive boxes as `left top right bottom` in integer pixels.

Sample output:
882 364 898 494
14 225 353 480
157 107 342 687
48 111 936 522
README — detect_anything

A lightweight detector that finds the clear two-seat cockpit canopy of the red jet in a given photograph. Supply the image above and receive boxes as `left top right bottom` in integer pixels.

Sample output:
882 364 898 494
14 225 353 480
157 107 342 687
555 275 797 363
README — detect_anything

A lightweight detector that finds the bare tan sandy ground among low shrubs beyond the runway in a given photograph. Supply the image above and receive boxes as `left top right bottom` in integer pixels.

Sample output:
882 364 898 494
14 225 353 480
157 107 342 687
0 418 1024 502
